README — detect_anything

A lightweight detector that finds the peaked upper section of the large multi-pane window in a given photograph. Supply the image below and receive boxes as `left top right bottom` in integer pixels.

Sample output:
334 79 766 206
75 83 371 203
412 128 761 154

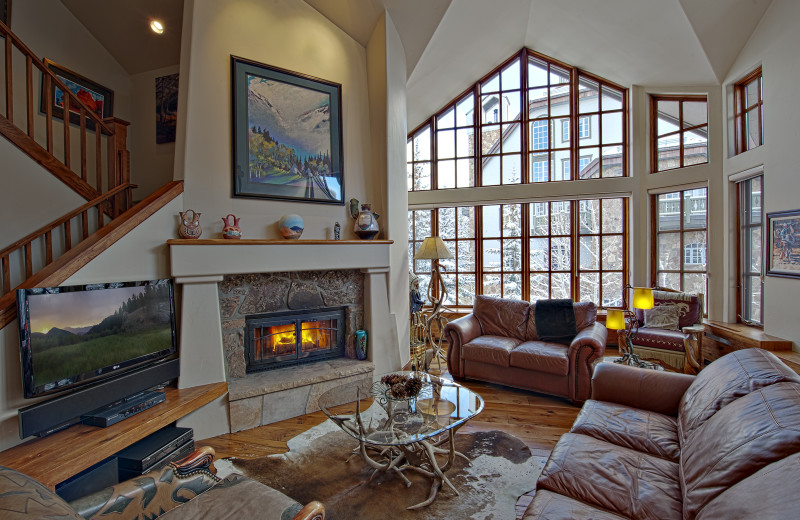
407 49 628 191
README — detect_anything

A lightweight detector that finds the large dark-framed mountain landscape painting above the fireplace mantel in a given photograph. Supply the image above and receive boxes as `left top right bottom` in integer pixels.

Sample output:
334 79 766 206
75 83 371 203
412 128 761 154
231 56 344 204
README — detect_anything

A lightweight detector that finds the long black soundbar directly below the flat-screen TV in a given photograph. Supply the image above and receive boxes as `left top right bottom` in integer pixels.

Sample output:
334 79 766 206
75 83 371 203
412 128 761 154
18 358 180 439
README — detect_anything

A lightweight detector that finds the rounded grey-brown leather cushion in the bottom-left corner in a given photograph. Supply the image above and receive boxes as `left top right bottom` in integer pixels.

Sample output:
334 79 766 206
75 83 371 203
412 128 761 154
0 466 83 520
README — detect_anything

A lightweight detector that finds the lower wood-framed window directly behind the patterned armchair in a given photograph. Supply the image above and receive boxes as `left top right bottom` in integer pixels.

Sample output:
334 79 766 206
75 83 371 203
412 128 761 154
651 188 708 297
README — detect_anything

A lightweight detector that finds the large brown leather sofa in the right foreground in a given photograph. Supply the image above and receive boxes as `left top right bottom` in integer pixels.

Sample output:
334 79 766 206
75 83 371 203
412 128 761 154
523 349 800 520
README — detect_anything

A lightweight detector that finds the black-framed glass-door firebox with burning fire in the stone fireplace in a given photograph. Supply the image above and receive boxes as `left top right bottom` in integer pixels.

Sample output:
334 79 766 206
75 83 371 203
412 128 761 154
245 307 346 372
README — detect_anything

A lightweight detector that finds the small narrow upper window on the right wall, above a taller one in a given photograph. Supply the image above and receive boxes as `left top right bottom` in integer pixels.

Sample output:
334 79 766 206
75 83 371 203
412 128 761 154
734 67 764 154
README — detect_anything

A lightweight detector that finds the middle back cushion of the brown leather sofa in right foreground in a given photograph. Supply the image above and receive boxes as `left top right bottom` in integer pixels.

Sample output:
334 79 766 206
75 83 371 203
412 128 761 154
681 383 800 518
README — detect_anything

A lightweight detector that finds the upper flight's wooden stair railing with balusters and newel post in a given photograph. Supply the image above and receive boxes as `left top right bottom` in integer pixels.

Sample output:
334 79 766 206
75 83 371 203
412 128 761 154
0 22 132 214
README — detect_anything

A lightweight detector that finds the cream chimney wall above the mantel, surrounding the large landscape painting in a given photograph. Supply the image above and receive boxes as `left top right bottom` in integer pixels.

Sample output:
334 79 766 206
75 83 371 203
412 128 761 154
176 0 376 239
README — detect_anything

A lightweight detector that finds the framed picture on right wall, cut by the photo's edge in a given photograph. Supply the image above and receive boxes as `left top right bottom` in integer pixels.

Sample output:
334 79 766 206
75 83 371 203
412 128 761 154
766 209 800 278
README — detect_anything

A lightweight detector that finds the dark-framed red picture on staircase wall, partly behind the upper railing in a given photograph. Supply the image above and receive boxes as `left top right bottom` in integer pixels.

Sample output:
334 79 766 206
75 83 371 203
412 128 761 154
40 58 114 127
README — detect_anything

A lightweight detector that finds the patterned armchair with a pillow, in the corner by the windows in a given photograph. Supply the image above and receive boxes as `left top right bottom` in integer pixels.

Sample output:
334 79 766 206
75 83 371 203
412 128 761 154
618 288 703 374
